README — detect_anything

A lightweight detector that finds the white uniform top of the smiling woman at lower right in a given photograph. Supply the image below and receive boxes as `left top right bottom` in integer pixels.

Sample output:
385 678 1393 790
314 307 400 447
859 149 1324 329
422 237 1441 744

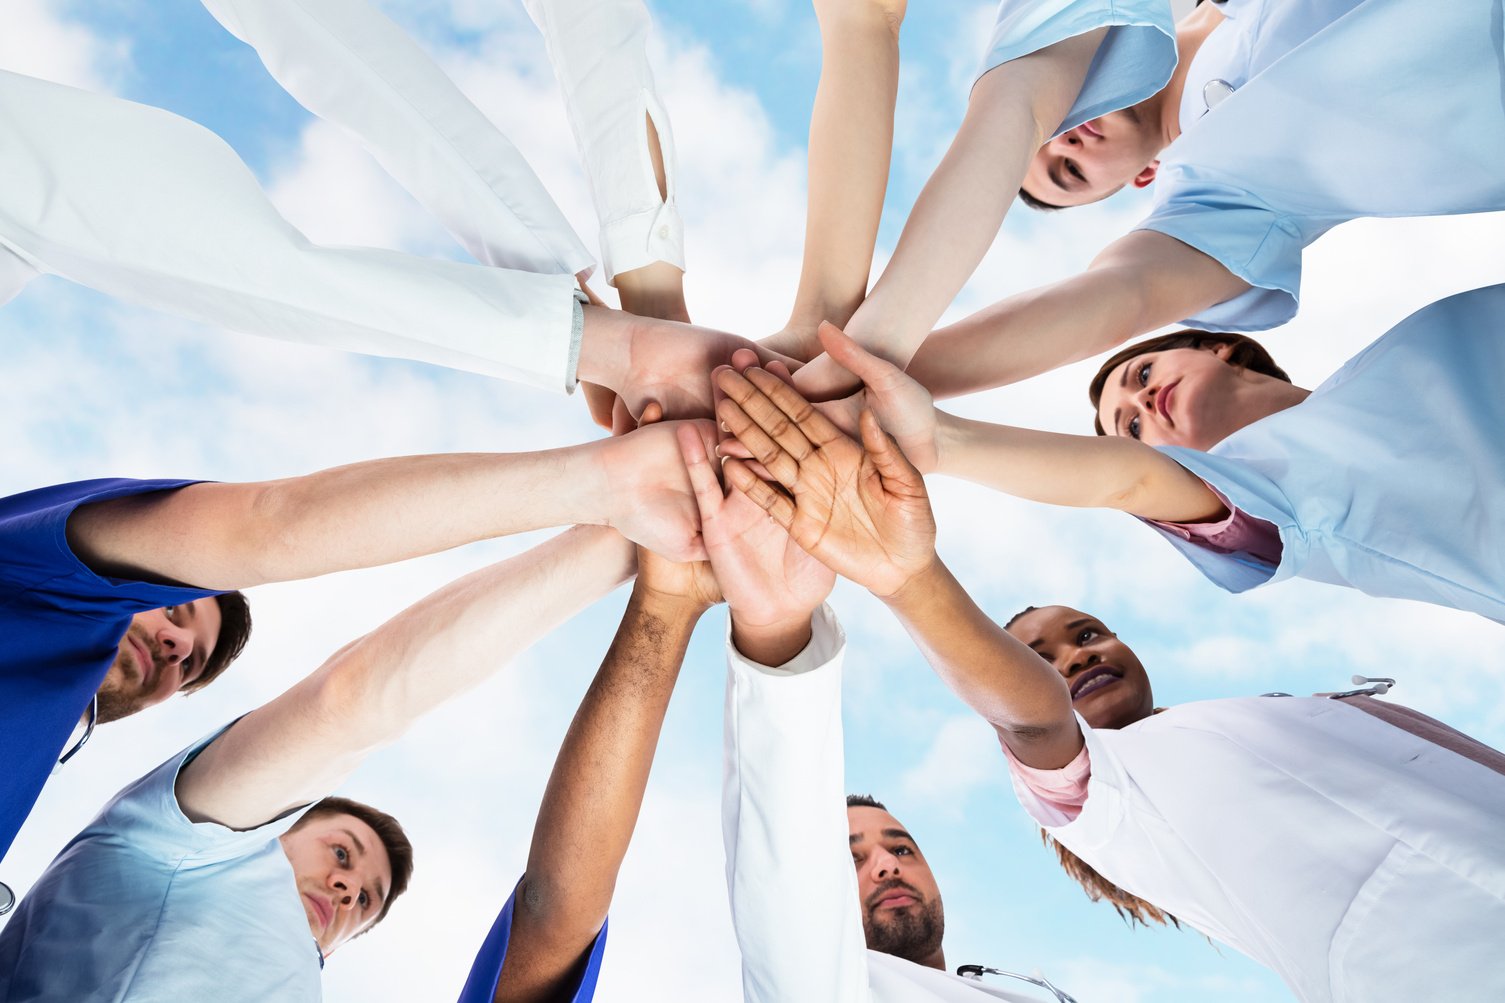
1014 697 1505 1003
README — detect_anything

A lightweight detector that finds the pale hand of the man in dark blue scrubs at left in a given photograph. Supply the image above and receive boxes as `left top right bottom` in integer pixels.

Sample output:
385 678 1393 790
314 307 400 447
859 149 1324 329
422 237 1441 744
594 405 716 562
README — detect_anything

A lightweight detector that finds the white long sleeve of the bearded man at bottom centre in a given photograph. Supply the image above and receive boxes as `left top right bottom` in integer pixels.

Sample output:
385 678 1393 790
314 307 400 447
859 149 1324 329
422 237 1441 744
721 607 870 1003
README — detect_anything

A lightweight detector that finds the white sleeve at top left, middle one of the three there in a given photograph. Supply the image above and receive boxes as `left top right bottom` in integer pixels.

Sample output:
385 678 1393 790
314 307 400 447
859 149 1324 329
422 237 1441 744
202 0 594 274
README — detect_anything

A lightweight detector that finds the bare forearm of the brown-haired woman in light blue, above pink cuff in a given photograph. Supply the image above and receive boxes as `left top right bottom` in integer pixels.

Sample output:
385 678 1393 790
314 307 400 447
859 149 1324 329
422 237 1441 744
936 411 1222 523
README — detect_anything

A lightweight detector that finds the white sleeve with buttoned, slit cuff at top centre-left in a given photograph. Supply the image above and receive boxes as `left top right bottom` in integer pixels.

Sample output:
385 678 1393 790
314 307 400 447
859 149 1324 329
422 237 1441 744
524 0 685 285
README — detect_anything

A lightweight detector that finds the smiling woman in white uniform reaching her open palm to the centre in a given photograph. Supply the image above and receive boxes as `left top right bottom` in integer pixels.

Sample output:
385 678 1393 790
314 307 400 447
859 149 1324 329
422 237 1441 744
719 369 1505 1001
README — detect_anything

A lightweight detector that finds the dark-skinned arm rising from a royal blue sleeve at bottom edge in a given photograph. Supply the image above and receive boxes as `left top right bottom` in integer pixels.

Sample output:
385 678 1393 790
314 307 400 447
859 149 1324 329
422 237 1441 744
497 550 721 1003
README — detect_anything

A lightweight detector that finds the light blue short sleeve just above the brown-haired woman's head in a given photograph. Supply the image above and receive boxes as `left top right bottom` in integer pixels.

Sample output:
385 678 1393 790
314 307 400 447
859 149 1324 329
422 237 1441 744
1135 164 1311 333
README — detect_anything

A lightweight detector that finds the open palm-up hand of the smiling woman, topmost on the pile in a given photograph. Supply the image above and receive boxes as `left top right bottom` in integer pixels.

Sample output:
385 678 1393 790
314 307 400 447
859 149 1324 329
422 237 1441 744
710 367 936 596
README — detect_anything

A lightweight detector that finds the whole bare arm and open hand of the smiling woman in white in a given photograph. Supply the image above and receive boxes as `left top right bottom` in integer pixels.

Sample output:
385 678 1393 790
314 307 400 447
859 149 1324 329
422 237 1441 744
719 369 1082 770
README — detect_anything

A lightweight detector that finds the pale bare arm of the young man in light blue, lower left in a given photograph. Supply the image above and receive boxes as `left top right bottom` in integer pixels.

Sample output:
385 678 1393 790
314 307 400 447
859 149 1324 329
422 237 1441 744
178 527 634 828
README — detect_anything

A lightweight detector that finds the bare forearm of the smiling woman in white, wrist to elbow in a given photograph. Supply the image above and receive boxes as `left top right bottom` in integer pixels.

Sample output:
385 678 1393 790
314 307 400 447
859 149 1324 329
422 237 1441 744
883 557 1082 768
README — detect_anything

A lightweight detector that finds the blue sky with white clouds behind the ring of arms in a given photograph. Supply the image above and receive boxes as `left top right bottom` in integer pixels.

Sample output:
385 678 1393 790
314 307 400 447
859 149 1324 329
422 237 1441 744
0 0 1505 1003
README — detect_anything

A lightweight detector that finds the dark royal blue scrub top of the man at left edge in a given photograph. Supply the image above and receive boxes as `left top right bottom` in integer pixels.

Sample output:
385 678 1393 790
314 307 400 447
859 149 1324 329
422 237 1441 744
0 477 218 857
